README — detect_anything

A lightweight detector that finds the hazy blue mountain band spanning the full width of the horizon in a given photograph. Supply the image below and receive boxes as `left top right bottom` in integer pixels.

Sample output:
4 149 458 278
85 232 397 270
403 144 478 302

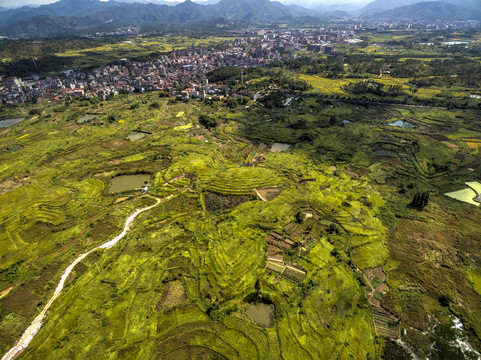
0 0 481 37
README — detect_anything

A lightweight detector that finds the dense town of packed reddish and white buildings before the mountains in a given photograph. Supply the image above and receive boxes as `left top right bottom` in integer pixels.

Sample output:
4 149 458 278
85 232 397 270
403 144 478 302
0 30 344 104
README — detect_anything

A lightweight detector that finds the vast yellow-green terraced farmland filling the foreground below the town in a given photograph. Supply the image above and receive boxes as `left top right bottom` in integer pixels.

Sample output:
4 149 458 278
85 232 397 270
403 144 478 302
0 85 479 360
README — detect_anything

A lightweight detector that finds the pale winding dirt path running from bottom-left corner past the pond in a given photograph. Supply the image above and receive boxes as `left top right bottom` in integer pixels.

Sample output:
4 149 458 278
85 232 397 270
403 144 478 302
2 194 169 360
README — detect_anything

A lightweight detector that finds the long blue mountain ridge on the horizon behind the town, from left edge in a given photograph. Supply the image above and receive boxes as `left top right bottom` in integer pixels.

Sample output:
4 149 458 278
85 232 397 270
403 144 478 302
0 0 322 37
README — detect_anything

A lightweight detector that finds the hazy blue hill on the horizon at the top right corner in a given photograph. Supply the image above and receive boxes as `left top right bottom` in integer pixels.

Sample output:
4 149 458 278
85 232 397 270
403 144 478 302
370 1 480 21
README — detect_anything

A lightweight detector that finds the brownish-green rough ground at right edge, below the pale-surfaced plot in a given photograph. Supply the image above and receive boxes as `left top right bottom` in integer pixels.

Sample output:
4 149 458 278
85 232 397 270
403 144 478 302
382 202 481 331
